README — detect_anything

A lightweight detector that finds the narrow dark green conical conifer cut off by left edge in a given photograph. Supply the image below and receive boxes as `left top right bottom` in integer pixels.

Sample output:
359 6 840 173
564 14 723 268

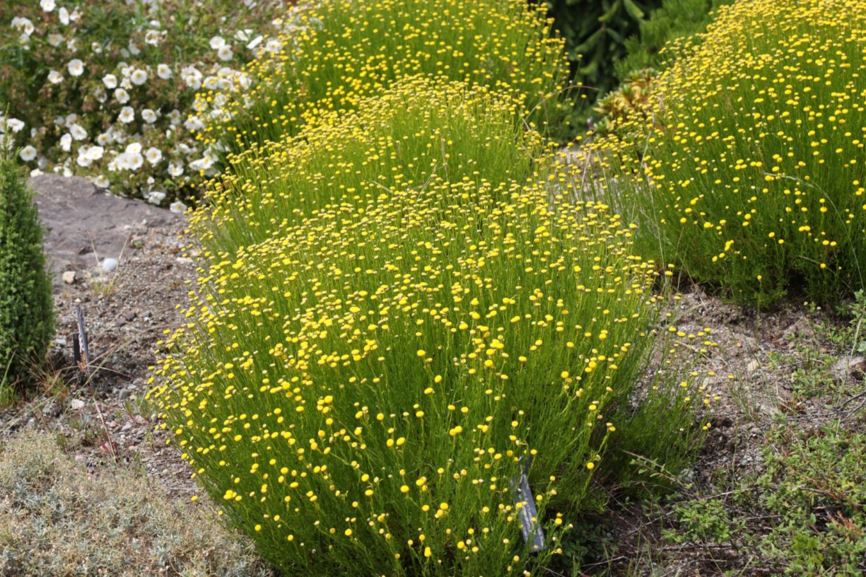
0 155 54 387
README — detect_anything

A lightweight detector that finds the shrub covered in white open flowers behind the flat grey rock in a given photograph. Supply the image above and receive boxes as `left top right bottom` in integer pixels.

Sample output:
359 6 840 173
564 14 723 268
0 0 292 204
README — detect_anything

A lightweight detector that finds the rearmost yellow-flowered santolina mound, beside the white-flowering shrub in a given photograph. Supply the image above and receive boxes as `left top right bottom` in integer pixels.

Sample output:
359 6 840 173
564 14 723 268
204 0 568 156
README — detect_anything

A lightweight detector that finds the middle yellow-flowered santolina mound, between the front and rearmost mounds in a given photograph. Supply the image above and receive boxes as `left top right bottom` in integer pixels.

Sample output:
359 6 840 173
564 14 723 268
192 77 543 254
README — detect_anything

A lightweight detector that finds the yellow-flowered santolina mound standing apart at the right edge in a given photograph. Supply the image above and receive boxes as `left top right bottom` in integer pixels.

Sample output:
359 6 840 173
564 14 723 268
596 0 866 305
